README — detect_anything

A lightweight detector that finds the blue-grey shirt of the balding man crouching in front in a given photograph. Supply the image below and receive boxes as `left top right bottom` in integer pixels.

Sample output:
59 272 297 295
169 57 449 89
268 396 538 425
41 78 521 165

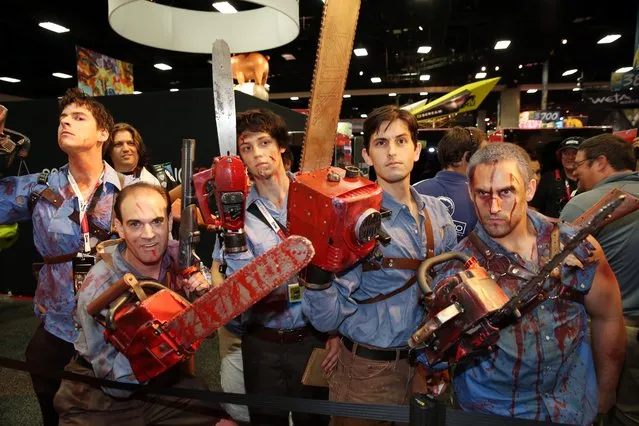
75 241 179 398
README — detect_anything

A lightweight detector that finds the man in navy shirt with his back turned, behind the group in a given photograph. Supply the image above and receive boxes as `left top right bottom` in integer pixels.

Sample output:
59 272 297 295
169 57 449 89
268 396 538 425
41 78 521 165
413 127 488 241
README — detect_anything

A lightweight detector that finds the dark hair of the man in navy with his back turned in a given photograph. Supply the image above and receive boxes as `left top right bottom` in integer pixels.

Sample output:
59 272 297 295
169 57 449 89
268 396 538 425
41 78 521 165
437 127 488 169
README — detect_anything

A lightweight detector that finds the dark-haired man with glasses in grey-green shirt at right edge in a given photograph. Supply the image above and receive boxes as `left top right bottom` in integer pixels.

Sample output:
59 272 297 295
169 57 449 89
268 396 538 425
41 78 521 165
560 134 639 426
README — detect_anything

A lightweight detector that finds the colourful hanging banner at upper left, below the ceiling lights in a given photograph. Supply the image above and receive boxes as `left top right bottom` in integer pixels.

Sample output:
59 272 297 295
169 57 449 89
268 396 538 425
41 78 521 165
75 46 133 96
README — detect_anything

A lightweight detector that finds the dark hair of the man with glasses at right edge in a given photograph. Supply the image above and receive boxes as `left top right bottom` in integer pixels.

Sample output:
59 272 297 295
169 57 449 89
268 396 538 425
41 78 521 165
579 133 635 171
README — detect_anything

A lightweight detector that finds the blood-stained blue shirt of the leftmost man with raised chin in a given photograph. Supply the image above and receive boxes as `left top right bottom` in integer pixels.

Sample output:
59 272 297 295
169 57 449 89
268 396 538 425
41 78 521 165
0 163 121 342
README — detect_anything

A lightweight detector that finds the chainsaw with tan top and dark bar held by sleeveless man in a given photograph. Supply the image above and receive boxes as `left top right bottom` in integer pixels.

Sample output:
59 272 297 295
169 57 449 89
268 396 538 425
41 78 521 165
408 194 628 365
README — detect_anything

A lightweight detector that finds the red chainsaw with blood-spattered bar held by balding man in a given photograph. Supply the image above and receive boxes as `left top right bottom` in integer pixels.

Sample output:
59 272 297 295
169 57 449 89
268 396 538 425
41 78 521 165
87 236 314 382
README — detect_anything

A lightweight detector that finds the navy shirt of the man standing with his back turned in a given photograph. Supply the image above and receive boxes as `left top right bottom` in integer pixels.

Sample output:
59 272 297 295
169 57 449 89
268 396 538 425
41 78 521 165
413 170 477 241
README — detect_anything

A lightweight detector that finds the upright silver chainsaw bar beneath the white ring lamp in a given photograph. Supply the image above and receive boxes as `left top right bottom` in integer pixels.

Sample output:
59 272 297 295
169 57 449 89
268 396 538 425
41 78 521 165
211 40 237 155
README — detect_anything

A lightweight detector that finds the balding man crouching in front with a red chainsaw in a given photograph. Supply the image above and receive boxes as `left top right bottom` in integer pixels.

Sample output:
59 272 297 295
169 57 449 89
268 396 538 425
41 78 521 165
55 183 234 426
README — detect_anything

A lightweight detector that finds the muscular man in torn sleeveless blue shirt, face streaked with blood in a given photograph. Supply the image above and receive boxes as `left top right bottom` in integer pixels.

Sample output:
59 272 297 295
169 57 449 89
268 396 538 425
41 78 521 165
424 143 625 425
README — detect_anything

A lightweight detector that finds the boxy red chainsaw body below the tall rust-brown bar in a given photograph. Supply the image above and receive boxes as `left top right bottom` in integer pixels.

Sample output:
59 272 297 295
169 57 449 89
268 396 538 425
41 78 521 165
287 167 382 272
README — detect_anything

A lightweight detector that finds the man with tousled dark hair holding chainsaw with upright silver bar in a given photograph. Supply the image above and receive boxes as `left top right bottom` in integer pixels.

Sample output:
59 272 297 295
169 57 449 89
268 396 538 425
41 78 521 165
213 110 337 426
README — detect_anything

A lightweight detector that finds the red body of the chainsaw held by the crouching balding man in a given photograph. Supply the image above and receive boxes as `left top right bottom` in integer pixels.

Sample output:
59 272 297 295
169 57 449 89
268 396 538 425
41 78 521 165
104 288 202 382
